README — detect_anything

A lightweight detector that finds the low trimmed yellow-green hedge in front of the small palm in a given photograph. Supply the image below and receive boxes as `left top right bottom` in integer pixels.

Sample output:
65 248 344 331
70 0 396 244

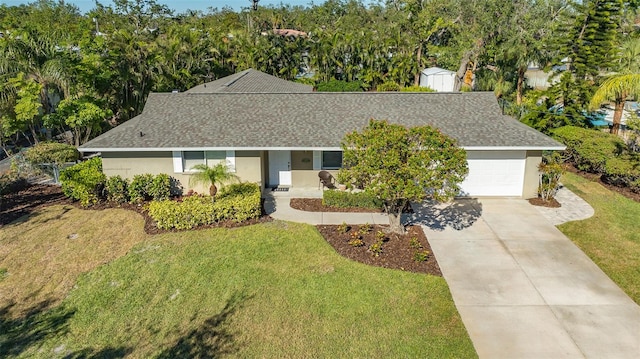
149 183 262 229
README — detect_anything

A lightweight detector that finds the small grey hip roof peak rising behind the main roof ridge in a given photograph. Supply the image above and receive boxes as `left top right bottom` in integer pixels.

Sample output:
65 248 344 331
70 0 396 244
185 69 313 93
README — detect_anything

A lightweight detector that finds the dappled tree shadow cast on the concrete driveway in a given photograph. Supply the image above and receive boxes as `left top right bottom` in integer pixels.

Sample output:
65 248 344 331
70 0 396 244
407 198 482 231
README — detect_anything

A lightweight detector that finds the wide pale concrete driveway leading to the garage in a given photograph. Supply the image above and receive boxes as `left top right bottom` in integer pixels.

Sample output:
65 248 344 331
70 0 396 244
415 199 640 359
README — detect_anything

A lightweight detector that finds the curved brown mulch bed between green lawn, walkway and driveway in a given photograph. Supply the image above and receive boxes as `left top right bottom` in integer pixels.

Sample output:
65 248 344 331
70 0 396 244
316 225 442 276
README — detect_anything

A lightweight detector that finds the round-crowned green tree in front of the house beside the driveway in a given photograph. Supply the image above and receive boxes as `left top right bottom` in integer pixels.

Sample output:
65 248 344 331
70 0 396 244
338 119 469 233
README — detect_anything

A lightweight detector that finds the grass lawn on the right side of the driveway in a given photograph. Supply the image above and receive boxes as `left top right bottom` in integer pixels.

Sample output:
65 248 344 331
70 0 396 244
558 173 640 304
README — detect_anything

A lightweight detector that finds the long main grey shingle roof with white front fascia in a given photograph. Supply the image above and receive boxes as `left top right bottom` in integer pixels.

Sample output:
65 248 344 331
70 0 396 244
80 92 564 152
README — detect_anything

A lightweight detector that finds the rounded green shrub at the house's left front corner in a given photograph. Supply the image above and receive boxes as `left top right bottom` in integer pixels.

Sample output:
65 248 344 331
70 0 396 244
60 157 106 206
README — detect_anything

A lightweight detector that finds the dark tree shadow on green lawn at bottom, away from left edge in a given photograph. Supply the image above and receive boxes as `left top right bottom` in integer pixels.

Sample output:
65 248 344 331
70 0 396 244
156 293 250 359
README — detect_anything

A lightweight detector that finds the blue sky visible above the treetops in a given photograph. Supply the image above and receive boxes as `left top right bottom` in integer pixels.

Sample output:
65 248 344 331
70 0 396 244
0 0 324 13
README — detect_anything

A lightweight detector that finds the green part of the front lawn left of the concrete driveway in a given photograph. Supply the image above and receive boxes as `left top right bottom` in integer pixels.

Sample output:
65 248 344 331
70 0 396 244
0 207 477 358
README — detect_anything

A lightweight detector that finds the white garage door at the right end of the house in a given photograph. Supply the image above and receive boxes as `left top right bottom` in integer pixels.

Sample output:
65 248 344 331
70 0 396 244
461 151 526 197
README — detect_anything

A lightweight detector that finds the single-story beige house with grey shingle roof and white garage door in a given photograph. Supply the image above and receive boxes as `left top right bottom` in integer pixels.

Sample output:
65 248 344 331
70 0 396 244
79 70 564 198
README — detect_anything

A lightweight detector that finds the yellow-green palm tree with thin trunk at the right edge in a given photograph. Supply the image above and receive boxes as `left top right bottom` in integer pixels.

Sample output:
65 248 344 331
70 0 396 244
589 74 640 134
